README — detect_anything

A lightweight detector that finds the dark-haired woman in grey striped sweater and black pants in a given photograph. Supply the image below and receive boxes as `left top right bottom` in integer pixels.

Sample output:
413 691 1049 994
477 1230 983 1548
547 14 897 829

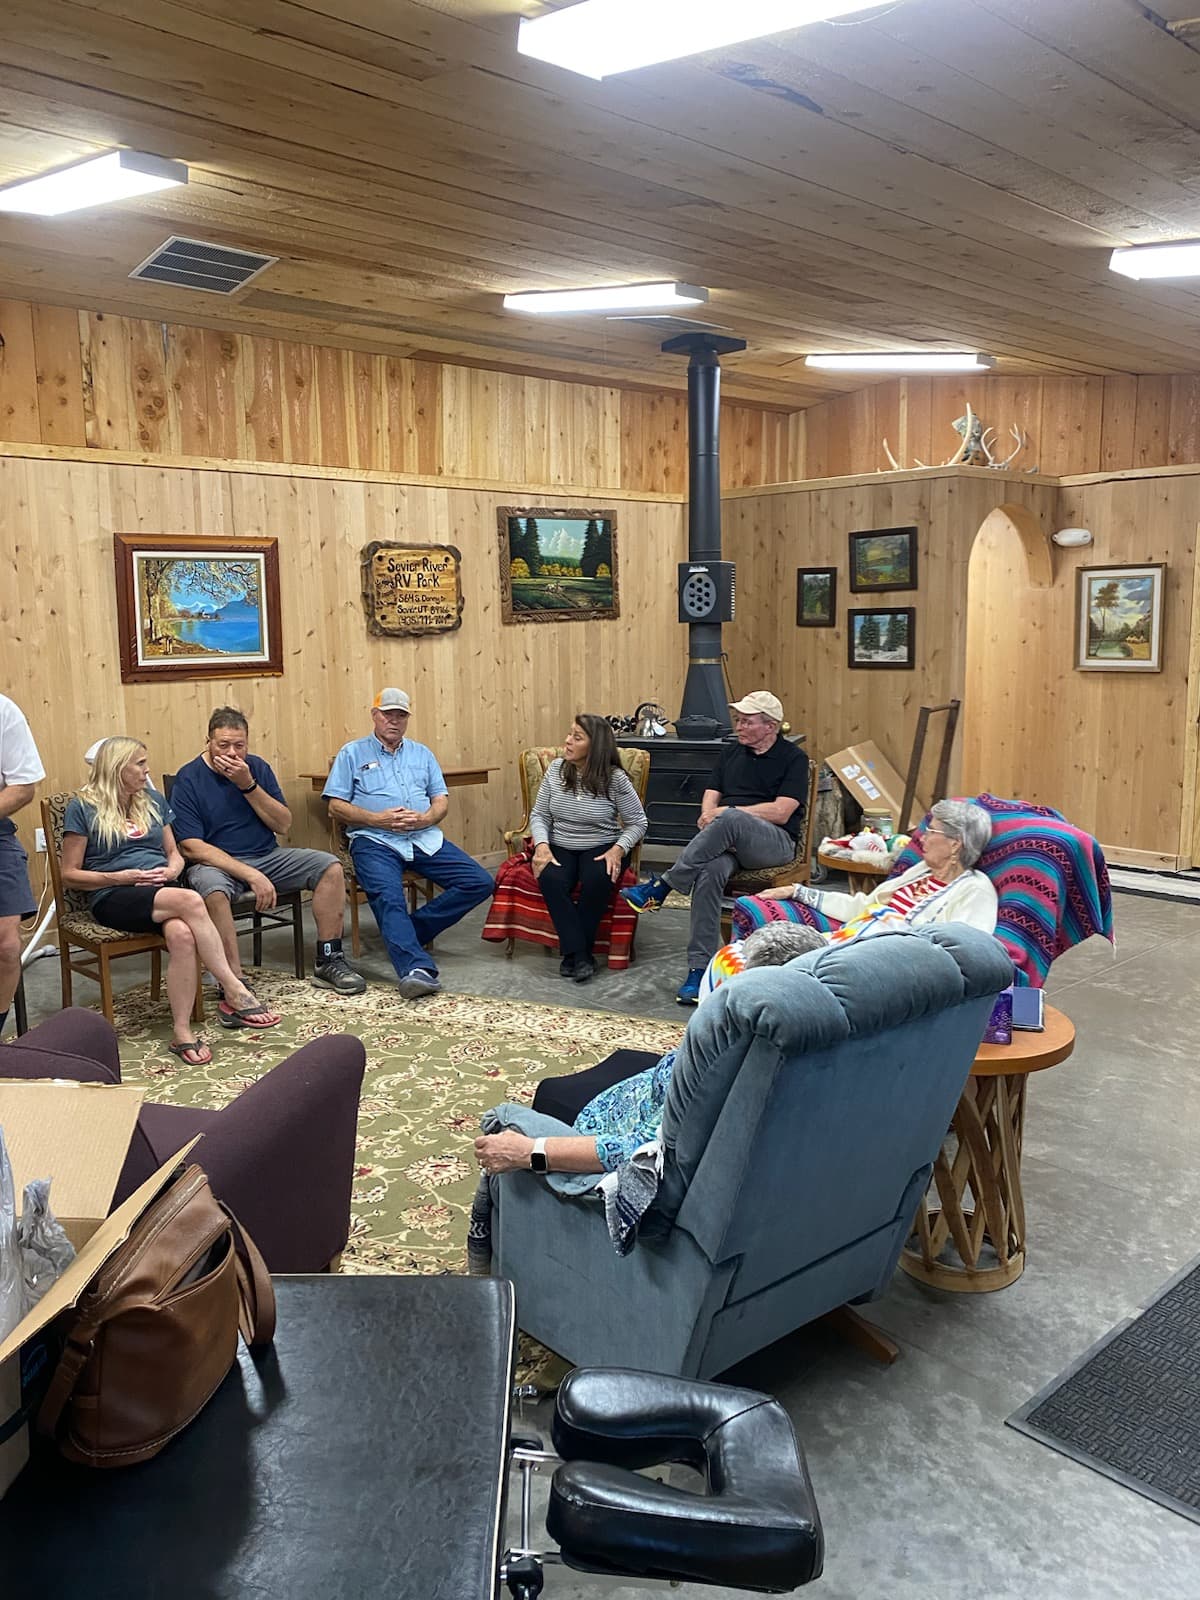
530 712 646 984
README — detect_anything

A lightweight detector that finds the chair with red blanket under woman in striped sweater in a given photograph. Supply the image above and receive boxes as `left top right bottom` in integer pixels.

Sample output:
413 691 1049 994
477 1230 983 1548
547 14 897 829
483 746 650 971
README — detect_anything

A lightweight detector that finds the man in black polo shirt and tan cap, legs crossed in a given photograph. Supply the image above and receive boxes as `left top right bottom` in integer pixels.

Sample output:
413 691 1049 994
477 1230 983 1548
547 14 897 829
621 690 808 1005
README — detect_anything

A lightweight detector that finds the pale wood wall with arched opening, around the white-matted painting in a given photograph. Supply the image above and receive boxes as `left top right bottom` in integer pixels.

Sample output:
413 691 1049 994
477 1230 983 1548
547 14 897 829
963 472 1200 866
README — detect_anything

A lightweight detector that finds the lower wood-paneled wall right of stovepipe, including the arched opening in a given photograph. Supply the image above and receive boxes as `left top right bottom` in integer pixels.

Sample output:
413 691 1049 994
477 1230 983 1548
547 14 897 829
725 469 1200 864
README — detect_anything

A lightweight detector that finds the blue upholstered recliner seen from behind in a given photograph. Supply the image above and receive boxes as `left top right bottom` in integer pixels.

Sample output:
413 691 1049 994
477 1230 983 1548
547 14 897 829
493 923 1013 1378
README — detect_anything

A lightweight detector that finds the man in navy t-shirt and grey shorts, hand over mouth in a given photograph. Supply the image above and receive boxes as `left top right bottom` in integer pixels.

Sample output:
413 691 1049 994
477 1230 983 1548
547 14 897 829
171 706 366 995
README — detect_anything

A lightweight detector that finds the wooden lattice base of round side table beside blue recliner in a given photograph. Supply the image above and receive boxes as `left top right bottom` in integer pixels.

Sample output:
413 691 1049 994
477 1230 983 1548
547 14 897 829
901 1072 1027 1294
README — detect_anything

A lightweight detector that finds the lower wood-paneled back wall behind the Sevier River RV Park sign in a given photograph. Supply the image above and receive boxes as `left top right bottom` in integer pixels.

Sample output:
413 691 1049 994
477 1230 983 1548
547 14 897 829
0 453 686 853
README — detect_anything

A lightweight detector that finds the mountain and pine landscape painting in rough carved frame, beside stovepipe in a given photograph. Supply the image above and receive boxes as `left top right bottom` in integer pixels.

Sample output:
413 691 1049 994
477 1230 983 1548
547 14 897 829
498 506 621 622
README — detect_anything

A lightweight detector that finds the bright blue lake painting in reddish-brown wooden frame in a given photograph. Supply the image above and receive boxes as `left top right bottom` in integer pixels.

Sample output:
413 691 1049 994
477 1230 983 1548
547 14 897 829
112 533 283 683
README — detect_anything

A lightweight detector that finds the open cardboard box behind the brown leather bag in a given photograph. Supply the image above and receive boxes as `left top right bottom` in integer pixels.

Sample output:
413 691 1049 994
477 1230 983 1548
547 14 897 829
0 1080 195 1496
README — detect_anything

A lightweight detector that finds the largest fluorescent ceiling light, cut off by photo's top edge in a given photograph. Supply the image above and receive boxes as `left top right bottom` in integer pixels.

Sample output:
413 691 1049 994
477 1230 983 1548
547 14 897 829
517 0 880 78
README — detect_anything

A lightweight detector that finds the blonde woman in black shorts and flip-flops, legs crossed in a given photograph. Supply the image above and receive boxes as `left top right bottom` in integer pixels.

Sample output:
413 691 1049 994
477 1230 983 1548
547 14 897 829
62 738 280 1067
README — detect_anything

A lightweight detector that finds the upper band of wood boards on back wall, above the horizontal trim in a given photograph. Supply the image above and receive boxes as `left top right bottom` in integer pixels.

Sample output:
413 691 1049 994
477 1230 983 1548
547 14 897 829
0 301 794 494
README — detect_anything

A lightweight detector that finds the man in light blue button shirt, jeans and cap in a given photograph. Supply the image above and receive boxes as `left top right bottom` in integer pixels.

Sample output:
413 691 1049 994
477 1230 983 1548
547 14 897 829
325 690 496 1000
